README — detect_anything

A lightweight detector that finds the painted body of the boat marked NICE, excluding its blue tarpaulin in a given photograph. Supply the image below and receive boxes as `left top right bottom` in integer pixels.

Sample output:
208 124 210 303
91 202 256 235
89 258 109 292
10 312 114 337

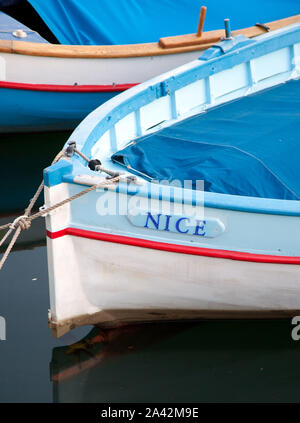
44 25 300 336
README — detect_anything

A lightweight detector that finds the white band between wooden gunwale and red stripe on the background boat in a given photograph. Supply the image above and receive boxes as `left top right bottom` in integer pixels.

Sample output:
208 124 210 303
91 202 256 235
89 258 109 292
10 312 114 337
0 51 201 85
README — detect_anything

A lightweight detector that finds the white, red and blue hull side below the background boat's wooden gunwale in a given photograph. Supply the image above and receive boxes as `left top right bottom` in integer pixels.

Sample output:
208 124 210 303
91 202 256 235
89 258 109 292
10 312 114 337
0 51 197 133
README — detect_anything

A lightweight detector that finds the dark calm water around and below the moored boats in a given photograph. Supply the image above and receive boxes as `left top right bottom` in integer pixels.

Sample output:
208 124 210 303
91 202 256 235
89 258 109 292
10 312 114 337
0 133 300 403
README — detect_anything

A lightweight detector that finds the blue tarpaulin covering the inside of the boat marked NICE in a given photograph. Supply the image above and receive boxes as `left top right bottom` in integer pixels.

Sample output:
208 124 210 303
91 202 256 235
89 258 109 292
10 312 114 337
112 81 300 200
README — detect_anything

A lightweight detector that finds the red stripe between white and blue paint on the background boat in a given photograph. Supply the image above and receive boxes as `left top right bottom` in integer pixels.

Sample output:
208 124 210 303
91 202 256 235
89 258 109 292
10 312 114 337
0 81 137 93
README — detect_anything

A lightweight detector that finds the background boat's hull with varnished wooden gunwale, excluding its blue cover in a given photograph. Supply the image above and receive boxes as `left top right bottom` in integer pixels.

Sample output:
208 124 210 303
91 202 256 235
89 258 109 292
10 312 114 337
0 15 300 132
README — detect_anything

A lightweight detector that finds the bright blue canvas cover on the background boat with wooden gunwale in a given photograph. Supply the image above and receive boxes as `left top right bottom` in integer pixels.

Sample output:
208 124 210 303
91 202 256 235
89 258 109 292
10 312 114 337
28 0 300 44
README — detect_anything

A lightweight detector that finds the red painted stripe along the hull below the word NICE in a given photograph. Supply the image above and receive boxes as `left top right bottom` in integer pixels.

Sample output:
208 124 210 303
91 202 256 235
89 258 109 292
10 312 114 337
47 228 300 264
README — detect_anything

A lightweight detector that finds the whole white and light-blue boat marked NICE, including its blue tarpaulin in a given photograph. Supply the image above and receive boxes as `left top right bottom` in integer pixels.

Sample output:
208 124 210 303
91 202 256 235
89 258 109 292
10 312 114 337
44 21 300 336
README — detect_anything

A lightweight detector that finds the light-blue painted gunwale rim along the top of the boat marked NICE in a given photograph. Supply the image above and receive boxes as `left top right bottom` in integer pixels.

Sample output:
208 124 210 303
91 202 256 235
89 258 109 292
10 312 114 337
45 24 300 216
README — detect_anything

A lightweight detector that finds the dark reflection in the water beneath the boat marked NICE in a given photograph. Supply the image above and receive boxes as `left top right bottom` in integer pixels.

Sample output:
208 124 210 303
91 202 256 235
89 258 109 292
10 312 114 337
51 321 300 403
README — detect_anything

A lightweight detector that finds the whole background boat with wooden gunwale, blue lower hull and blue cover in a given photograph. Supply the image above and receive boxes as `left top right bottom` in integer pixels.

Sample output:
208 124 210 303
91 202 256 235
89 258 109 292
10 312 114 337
0 0 300 132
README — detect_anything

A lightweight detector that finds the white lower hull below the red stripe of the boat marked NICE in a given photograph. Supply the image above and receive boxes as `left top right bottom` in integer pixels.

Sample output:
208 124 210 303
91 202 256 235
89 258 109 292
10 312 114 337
47 233 300 336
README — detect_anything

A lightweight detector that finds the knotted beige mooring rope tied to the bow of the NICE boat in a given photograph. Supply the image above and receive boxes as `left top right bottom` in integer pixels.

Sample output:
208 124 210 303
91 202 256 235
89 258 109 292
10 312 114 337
0 150 121 270
